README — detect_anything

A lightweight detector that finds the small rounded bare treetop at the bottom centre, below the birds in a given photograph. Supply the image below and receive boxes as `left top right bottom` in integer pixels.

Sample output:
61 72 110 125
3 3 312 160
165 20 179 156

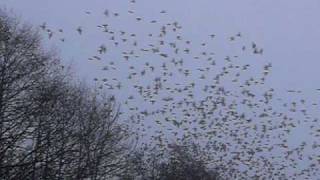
122 143 220 180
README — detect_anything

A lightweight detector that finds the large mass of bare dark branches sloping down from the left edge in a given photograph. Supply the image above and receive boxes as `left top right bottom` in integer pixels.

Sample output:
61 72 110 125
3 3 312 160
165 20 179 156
0 11 128 179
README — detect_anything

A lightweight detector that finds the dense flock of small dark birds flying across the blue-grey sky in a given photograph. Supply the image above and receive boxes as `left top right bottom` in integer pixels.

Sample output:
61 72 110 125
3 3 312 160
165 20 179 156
40 0 320 179
